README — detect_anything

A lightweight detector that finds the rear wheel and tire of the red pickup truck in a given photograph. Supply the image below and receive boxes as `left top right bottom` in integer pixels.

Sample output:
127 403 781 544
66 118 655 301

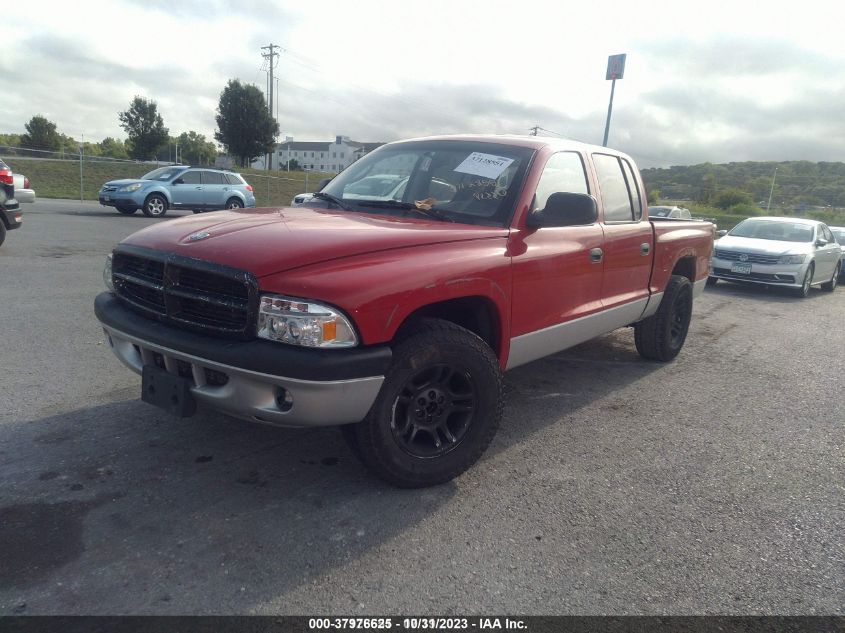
634 275 692 363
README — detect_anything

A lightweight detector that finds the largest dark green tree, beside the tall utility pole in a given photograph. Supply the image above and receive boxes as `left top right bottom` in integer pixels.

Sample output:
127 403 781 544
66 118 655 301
214 79 279 166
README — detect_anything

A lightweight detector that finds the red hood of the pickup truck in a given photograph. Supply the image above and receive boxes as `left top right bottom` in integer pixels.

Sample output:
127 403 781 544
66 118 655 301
121 207 508 278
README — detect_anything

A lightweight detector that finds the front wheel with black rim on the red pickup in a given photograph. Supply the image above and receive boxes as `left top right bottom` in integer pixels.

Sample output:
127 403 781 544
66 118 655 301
343 319 504 488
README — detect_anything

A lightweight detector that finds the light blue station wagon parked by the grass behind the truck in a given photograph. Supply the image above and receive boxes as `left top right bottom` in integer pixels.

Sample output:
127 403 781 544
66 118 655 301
99 165 255 218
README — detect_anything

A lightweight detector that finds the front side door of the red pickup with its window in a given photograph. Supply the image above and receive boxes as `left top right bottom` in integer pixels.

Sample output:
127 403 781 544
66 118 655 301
508 152 604 367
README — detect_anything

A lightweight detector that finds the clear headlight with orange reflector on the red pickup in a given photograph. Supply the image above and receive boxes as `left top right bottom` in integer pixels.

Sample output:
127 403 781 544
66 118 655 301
258 295 358 348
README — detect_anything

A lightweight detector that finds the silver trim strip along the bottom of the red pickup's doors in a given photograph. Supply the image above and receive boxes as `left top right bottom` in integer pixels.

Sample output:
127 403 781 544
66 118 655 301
506 298 648 369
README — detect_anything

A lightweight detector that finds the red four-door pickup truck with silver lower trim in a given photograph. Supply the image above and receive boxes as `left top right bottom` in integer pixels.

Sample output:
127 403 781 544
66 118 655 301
95 136 714 487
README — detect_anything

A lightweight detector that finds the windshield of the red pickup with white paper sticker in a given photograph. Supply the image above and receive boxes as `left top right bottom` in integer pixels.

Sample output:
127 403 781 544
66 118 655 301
316 140 534 226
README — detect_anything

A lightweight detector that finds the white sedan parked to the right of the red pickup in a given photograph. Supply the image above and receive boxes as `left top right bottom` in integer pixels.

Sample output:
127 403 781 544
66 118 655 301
707 217 842 297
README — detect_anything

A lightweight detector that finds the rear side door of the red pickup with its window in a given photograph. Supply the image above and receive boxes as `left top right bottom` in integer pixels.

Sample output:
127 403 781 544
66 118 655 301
593 154 654 312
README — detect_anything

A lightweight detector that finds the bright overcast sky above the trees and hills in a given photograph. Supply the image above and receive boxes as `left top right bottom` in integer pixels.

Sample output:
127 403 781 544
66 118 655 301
6 0 845 166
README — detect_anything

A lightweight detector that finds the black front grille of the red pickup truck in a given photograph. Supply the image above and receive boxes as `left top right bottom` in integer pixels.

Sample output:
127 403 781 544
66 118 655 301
112 246 258 339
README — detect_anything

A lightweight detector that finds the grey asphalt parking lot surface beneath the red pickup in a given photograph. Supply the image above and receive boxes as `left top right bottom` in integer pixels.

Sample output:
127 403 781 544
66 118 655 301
0 200 845 614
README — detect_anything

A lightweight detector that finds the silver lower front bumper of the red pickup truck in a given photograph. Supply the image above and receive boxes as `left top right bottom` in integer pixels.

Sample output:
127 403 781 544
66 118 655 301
103 327 384 427
